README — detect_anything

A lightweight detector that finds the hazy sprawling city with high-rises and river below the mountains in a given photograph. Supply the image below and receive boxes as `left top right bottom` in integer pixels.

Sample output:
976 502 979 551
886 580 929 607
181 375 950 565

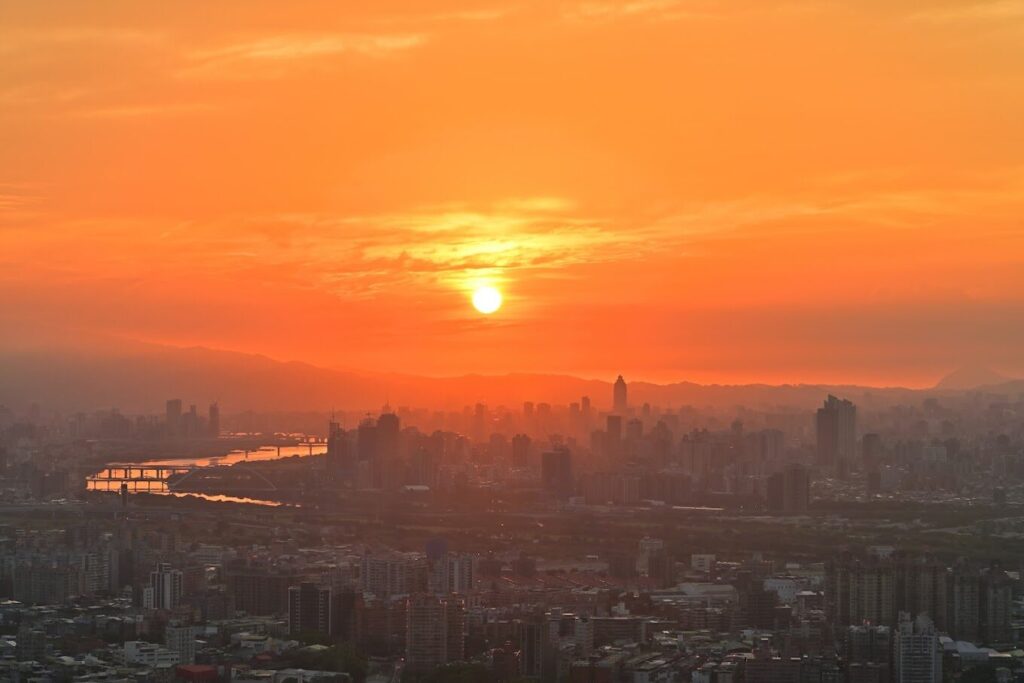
0 376 1024 683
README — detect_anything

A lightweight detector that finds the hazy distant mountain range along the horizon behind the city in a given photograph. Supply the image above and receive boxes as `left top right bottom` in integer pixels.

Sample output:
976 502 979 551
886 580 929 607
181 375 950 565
0 345 1024 413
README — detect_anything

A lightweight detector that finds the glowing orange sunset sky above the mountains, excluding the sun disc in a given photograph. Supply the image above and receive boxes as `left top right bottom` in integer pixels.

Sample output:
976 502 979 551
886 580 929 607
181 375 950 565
0 0 1024 385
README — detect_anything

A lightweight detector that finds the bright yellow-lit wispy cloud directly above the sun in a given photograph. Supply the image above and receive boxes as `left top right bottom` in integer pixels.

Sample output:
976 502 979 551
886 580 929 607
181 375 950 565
260 197 626 295
